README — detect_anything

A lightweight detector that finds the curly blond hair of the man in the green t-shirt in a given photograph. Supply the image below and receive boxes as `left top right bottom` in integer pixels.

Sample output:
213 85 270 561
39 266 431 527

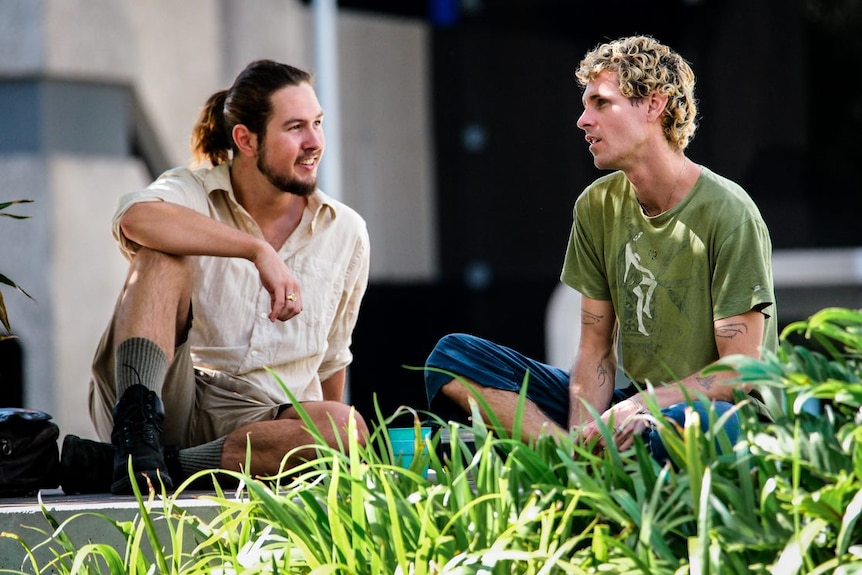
575 36 697 150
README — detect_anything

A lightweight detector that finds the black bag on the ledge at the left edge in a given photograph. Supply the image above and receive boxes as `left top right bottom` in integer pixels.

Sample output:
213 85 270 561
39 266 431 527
0 407 60 497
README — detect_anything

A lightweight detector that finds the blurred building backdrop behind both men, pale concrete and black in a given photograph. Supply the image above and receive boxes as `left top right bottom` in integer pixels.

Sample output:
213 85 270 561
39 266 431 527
0 0 862 435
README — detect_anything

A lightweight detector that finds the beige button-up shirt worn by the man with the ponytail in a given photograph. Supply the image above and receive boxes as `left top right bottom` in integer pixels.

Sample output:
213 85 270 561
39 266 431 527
113 164 370 404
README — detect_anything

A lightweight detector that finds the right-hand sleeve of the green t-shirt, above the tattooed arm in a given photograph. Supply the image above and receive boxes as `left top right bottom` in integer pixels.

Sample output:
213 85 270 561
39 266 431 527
712 219 775 320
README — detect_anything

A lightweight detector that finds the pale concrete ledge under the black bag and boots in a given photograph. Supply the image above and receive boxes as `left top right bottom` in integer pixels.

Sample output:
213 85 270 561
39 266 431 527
0 489 221 571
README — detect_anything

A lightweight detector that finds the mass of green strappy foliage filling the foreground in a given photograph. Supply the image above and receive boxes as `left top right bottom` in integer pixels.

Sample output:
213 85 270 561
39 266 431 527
4 310 862 575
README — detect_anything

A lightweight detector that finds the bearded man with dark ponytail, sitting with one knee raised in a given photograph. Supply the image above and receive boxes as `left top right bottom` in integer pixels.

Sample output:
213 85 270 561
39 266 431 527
61 60 369 493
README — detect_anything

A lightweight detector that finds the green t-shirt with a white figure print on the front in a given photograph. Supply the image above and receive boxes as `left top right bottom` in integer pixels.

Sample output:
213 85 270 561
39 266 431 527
561 168 778 385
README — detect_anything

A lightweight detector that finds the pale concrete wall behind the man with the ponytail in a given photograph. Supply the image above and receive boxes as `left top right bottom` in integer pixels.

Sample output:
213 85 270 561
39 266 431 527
0 0 436 436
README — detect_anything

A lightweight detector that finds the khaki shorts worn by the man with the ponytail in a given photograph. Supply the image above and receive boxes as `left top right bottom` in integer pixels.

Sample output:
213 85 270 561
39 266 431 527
90 312 281 447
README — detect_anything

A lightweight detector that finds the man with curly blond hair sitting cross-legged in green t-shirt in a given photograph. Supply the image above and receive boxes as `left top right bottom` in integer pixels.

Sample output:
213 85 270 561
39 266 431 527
425 36 777 459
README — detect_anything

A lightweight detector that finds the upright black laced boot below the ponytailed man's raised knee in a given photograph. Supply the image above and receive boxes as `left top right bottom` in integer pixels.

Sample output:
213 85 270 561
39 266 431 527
111 385 174 494
